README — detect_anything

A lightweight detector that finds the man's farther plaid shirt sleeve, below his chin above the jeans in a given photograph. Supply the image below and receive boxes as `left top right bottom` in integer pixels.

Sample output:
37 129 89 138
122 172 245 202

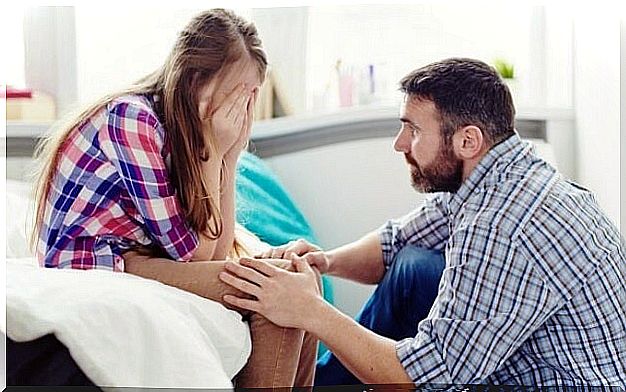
378 193 449 269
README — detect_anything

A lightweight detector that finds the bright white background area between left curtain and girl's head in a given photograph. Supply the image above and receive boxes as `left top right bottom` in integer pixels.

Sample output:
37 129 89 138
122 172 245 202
75 4 204 103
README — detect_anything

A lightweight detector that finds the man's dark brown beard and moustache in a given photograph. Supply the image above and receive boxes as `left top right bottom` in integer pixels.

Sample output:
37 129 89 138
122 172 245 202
404 142 463 193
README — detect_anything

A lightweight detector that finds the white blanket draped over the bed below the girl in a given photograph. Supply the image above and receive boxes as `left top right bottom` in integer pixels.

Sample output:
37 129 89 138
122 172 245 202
6 258 251 388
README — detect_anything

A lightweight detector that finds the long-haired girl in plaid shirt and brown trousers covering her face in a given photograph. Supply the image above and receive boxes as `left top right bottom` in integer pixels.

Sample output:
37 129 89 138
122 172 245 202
33 9 316 387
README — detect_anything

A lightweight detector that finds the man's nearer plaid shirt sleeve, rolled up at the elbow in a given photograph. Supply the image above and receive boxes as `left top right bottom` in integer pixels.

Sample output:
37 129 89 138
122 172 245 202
396 226 562 385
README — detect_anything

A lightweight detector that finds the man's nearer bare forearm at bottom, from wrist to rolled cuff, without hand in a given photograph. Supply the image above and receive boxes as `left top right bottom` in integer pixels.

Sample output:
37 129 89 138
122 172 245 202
305 301 412 384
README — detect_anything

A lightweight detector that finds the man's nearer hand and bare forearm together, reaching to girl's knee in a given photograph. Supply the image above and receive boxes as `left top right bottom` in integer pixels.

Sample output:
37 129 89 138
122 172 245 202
219 256 412 384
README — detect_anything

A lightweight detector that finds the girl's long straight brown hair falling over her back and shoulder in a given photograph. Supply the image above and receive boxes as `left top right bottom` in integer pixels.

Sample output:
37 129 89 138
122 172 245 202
31 9 267 251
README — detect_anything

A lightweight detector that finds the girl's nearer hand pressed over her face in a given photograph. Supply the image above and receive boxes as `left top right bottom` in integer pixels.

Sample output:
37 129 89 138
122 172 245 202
200 83 252 157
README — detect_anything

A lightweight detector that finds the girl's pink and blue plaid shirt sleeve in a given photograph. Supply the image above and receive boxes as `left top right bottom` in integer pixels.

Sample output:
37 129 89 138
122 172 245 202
99 102 198 261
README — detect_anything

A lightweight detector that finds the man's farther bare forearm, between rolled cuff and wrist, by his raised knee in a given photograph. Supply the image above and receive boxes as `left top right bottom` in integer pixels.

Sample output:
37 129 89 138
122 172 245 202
327 232 385 284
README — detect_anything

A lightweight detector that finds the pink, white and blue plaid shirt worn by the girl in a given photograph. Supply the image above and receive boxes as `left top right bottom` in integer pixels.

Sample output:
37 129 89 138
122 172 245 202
37 95 198 271
